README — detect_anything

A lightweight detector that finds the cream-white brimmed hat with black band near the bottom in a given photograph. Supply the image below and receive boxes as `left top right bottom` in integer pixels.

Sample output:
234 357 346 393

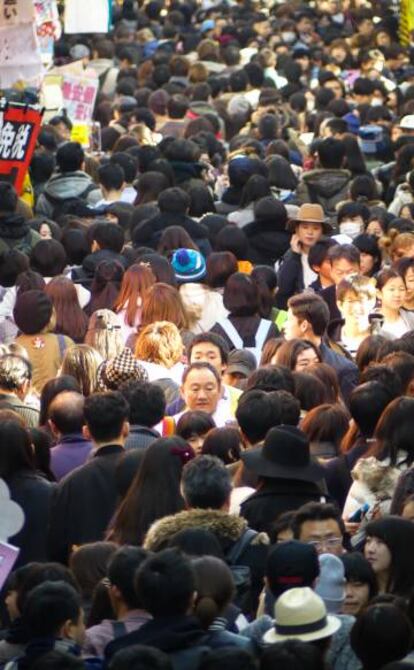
263 586 341 644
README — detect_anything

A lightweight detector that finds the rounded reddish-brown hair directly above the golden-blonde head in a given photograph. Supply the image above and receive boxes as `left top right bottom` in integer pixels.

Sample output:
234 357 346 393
141 283 188 330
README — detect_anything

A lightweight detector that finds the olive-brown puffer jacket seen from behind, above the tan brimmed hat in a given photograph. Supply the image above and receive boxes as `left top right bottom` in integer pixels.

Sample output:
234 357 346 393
296 169 352 217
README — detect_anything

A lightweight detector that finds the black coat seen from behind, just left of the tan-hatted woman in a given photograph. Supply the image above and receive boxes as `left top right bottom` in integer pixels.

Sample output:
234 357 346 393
243 221 291 267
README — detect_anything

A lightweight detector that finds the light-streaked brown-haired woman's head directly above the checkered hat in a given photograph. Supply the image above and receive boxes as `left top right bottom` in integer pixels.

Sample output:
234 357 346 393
84 309 125 361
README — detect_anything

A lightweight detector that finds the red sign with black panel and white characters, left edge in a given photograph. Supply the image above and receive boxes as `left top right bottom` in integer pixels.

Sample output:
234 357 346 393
0 103 42 195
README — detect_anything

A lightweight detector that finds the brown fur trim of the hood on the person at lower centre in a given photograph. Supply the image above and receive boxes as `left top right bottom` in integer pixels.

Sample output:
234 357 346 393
144 509 269 551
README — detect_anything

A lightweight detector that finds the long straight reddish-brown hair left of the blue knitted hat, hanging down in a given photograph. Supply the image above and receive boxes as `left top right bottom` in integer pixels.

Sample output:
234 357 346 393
114 263 156 326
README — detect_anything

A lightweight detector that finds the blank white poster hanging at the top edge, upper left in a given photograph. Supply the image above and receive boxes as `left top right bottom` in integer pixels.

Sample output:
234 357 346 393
65 0 111 34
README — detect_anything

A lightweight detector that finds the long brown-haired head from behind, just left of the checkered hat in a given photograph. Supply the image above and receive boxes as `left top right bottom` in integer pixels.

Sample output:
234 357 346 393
60 344 102 397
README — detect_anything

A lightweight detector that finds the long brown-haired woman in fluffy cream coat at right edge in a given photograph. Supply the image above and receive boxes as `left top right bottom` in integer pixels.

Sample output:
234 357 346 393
343 396 414 519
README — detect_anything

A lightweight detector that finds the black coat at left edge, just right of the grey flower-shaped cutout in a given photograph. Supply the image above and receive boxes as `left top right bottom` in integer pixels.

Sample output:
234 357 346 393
7 470 55 568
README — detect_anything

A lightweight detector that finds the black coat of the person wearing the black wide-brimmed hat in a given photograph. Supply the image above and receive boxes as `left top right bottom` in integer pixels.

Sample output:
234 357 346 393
240 478 322 533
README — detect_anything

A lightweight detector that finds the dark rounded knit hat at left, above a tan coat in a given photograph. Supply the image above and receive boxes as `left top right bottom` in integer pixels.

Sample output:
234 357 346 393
13 290 53 335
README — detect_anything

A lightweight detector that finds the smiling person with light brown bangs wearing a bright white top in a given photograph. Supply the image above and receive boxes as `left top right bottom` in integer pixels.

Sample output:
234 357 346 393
336 275 376 356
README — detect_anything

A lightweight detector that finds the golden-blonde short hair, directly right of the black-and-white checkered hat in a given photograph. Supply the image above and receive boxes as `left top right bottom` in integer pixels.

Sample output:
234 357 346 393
135 321 183 369
